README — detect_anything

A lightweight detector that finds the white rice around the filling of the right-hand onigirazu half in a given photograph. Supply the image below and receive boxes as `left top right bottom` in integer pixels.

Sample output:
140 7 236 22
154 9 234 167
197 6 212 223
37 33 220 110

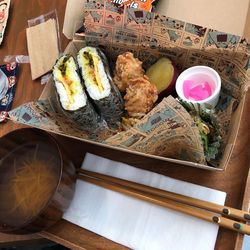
77 47 111 100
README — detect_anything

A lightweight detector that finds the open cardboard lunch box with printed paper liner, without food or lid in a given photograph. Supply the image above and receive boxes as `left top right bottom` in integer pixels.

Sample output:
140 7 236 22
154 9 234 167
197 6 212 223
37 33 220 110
7 0 250 171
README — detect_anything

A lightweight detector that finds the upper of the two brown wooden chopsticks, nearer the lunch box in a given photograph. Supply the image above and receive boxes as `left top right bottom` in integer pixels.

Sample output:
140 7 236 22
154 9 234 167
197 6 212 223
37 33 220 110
78 169 250 222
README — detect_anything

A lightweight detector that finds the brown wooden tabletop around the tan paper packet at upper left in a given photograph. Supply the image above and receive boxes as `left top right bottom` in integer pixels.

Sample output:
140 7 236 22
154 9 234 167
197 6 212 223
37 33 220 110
0 0 68 136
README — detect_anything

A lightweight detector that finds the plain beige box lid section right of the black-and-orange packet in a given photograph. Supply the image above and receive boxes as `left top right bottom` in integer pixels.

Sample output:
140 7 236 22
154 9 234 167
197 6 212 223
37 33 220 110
156 0 250 38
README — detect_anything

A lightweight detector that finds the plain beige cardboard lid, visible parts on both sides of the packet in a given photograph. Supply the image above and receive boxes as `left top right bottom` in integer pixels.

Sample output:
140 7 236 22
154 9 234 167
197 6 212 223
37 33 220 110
63 0 250 39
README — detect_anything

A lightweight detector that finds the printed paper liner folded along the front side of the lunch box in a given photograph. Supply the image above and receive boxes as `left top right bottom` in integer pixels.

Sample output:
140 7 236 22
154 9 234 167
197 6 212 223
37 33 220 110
7 86 206 164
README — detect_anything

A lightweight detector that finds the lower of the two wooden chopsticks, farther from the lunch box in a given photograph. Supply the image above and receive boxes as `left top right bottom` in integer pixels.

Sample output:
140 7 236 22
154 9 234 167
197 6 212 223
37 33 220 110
78 171 250 235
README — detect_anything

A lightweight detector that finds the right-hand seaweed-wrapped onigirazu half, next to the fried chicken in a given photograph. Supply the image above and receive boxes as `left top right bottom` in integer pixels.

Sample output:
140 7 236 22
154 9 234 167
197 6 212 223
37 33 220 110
77 47 124 128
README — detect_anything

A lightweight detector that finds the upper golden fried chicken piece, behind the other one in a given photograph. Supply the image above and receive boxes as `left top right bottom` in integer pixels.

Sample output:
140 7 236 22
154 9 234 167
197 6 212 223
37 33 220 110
114 52 145 92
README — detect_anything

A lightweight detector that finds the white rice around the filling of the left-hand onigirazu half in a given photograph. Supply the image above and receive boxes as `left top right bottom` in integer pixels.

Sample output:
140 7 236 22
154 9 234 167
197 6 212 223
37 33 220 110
53 56 87 111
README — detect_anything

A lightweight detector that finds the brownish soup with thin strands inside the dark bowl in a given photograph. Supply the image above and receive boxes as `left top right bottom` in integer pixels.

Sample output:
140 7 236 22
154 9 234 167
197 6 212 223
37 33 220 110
0 142 61 227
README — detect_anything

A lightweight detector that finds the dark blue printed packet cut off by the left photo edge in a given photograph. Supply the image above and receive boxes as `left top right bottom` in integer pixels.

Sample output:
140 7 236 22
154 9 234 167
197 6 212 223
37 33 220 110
0 62 18 123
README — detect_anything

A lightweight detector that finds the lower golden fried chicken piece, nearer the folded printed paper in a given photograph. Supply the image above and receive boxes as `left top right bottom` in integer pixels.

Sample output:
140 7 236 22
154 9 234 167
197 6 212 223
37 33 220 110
124 76 158 118
